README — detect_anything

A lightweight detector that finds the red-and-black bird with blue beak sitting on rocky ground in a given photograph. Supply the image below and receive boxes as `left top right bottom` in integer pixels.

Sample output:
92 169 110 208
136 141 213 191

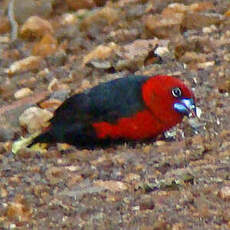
28 75 196 149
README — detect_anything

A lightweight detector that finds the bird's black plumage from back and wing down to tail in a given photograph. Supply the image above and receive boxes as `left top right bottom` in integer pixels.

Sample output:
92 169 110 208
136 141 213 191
30 76 148 148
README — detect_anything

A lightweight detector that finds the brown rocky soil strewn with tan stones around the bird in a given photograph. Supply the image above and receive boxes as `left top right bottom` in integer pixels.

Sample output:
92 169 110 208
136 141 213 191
0 0 230 230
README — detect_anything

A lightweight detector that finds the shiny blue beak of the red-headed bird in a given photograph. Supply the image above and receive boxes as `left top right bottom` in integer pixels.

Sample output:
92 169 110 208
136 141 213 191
174 98 197 117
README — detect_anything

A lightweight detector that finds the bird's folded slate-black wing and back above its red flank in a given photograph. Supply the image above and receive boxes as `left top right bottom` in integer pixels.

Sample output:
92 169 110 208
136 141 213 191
51 76 148 126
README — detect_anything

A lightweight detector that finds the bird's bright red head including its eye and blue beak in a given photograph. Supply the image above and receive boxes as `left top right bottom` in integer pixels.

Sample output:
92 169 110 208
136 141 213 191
142 75 196 128
